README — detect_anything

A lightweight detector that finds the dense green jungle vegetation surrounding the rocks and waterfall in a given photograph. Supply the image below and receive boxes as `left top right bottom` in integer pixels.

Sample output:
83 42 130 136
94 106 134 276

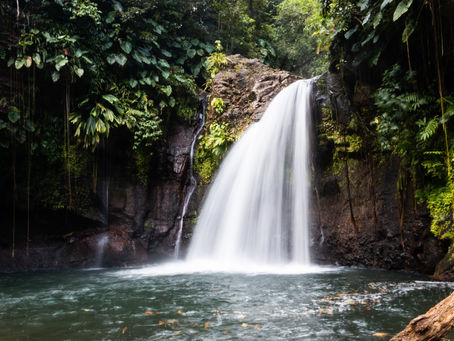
0 0 454 256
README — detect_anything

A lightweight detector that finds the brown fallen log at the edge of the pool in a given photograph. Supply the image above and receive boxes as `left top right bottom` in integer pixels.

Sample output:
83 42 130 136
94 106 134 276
390 292 454 341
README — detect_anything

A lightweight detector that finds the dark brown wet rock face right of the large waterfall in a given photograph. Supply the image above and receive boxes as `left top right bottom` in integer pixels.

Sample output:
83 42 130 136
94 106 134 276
312 74 447 274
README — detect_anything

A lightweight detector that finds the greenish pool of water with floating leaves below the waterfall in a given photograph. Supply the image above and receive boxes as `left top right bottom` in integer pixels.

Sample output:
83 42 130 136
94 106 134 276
0 264 454 341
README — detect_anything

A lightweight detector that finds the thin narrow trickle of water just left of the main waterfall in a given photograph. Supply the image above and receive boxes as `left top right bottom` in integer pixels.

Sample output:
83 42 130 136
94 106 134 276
174 98 207 258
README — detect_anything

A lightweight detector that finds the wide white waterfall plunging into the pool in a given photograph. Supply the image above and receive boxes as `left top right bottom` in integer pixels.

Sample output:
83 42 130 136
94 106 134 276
187 80 312 266
